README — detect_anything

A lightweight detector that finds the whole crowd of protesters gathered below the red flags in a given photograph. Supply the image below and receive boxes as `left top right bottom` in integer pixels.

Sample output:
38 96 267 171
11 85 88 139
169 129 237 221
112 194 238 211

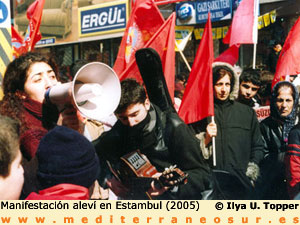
0 49 300 200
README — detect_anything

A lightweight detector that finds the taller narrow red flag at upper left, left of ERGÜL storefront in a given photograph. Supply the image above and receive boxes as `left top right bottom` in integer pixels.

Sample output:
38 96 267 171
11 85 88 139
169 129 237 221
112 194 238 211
24 0 45 51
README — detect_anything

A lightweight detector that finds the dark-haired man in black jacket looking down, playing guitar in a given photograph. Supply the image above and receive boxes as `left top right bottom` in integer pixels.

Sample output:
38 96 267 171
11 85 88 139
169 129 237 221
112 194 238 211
94 79 211 199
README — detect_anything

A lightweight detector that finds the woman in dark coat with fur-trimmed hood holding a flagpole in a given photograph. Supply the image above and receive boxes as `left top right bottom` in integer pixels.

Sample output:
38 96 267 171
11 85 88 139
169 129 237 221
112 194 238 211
192 63 263 199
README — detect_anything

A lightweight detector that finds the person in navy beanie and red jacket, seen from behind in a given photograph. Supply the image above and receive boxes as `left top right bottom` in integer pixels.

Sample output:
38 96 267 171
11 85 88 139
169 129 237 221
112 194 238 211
26 126 100 200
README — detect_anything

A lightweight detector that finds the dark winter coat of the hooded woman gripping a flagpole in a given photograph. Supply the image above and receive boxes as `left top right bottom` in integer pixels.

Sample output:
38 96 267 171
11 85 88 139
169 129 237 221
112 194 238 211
192 99 263 197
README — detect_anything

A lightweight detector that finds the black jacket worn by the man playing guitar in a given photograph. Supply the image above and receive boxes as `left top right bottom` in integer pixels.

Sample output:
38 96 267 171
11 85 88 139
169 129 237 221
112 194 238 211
95 106 211 199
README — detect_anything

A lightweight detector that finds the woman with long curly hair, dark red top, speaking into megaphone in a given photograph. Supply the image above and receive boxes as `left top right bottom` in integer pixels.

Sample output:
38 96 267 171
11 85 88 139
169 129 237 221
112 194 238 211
0 52 84 199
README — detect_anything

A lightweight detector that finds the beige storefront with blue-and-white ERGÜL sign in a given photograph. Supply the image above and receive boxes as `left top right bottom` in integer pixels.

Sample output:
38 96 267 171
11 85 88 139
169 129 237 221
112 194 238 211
14 0 129 79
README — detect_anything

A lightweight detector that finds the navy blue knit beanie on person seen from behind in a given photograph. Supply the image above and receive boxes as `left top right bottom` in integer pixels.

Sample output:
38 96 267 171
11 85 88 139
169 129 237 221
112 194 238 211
37 126 100 189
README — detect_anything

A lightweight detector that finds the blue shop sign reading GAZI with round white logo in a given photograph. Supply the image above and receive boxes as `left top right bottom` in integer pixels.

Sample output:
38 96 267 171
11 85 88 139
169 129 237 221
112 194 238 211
176 0 232 25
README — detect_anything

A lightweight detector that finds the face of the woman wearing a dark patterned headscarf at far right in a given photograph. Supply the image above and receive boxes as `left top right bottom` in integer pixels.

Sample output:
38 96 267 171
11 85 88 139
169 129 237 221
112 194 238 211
276 87 294 117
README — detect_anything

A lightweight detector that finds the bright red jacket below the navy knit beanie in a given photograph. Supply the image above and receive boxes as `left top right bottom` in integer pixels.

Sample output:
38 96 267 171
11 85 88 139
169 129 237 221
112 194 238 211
26 184 89 200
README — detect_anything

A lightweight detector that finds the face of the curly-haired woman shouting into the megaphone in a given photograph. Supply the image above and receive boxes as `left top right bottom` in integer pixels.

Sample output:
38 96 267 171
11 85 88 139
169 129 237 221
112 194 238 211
24 62 57 103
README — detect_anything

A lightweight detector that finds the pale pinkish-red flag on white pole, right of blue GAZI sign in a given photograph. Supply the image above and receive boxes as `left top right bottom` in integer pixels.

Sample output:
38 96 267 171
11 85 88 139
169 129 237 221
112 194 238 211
223 0 258 46
